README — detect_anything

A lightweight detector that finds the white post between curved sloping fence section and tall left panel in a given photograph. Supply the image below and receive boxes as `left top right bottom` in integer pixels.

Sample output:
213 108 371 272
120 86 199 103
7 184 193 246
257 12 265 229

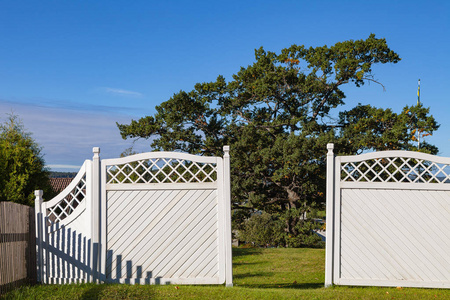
91 147 103 282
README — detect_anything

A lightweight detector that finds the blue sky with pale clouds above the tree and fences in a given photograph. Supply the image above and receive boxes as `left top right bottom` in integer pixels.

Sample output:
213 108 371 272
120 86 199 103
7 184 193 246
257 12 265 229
0 0 450 171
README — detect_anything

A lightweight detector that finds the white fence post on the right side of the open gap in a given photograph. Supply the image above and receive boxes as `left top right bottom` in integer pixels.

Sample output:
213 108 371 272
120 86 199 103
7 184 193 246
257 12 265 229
325 143 335 287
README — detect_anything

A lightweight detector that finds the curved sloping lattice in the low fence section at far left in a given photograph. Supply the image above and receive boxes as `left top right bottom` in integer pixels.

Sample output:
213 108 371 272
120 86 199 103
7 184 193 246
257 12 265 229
47 175 86 224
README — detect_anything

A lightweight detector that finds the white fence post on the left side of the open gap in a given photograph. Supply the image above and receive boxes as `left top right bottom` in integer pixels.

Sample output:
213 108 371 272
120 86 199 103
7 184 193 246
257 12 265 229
223 146 233 287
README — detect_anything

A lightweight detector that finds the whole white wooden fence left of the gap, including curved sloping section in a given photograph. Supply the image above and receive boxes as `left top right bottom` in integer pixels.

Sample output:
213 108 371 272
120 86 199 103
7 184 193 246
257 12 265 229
36 146 232 286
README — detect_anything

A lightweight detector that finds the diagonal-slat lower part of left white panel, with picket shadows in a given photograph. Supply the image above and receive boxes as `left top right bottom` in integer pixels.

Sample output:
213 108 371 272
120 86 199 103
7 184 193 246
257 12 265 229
107 190 218 279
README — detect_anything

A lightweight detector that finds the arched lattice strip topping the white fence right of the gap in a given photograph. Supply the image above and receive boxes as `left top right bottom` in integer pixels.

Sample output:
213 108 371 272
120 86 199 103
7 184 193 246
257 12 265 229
341 157 450 184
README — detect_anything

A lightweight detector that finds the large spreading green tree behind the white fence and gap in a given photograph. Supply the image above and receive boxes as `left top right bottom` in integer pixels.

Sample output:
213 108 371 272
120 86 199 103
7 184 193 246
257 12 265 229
117 34 438 239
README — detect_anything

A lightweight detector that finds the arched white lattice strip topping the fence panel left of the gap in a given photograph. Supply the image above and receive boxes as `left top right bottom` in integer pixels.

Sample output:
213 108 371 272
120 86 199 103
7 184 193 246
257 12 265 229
106 158 217 184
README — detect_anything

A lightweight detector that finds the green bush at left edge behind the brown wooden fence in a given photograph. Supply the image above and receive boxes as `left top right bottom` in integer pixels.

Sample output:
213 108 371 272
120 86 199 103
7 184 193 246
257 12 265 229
0 115 53 205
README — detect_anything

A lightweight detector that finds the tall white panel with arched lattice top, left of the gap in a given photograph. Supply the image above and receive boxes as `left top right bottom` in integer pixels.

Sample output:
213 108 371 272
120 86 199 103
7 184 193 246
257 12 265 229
102 152 231 285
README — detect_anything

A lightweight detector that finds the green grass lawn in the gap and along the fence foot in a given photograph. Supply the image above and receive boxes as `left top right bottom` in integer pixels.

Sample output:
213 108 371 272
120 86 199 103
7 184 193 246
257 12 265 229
4 249 450 299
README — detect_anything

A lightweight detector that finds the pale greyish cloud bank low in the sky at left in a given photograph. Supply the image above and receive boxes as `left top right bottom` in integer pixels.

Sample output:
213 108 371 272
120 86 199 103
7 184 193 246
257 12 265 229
0 100 150 171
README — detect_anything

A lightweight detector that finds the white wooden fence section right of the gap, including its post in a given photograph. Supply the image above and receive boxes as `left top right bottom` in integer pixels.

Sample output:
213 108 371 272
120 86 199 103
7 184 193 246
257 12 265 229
325 144 450 288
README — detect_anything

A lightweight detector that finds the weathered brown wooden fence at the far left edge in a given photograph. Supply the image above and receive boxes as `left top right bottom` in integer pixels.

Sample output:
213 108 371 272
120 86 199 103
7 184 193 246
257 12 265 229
0 202 36 295
